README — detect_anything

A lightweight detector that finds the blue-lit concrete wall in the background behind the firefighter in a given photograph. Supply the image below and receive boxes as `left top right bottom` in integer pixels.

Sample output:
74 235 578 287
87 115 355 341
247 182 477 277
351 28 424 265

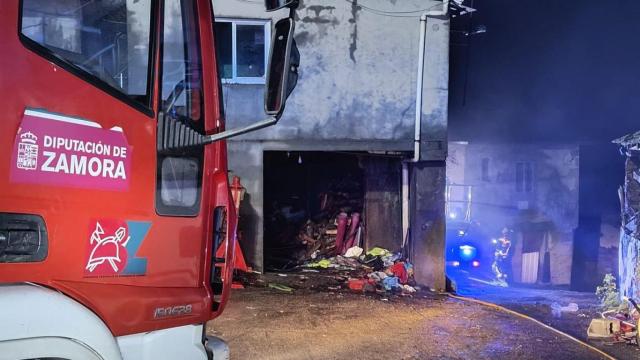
447 143 579 285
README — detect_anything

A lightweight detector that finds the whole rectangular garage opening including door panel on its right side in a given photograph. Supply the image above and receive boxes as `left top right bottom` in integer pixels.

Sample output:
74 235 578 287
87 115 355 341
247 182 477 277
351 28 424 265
263 151 402 271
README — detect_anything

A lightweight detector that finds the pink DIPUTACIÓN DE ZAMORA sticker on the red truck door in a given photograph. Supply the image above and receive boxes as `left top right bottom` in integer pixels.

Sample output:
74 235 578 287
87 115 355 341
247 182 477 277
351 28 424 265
10 109 132 191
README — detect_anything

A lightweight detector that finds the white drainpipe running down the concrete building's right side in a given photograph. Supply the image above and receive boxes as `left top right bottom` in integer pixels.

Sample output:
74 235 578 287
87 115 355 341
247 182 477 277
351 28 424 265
402 0 449 252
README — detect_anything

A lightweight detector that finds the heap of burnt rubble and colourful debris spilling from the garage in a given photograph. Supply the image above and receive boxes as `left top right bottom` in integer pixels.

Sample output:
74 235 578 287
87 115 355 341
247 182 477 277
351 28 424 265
268 178 417 296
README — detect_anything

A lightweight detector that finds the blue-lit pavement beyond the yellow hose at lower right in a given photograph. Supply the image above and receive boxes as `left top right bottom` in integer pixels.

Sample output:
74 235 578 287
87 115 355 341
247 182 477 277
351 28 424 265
458 281 640 360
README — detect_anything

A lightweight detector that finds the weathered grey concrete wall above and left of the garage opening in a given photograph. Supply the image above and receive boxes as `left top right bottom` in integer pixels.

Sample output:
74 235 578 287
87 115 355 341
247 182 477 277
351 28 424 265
213 0 449 269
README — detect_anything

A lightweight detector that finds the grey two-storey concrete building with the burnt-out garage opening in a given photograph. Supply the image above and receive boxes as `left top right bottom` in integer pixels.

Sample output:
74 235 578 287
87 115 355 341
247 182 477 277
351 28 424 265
214 0 449 288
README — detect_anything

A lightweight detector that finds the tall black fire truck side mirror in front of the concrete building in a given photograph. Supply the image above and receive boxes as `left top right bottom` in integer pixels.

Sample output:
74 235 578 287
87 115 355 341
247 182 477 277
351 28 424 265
264 17 300 118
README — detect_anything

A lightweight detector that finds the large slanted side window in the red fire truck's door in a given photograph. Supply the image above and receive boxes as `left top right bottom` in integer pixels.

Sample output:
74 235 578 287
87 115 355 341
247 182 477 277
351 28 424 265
21 0 151 106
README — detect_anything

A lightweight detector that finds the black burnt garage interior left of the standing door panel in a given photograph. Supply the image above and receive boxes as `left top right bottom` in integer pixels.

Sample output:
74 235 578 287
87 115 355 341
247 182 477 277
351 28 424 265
264 151 365 270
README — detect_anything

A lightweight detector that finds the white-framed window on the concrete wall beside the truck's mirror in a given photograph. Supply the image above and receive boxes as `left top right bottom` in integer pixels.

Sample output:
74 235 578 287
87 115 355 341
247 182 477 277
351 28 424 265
215 19 271 84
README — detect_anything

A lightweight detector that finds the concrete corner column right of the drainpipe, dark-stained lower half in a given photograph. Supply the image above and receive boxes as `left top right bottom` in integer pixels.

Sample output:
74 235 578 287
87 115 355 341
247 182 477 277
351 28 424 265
410 14 449 290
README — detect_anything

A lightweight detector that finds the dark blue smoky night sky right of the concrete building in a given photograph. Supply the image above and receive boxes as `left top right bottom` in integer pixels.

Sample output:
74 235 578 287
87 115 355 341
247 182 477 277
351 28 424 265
450 0 640 143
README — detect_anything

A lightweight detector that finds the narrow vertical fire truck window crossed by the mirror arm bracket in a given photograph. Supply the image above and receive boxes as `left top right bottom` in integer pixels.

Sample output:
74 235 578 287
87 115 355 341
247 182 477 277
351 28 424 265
156 0 204 216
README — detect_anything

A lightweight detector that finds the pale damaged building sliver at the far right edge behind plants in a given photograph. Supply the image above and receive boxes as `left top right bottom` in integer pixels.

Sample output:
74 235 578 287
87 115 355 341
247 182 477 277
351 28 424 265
613 131 640 299
